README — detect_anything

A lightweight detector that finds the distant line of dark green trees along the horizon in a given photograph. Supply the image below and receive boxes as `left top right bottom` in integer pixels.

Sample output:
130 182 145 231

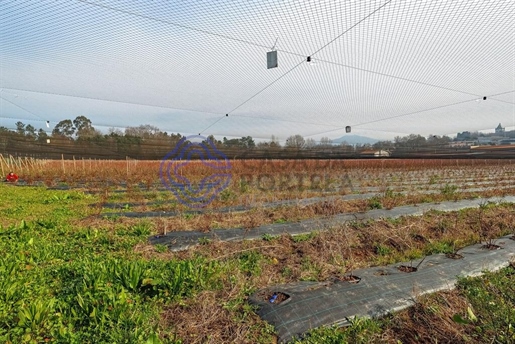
0 116 512 160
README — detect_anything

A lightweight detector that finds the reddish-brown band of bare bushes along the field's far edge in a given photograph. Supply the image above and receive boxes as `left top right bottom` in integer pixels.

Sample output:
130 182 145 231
10 158 515 186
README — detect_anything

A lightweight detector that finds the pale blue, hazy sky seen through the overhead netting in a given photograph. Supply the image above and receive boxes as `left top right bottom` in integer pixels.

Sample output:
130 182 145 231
0 0 515 141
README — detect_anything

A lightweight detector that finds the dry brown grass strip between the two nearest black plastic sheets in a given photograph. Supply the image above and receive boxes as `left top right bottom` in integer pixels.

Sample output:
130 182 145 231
149 205 515 280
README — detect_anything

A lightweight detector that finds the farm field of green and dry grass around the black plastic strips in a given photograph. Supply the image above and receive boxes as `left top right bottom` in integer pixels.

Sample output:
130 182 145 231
0 159 515 343
